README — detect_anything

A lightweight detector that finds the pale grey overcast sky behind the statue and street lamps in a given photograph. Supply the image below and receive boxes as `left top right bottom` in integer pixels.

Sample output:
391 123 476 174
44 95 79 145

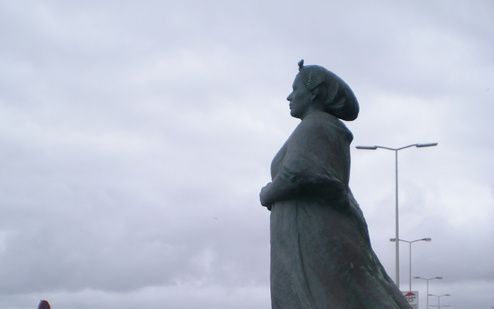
0 0 494 309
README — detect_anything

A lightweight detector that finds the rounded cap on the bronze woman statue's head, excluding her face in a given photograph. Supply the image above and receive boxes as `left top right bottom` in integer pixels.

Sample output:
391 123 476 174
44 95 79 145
296 60 359 121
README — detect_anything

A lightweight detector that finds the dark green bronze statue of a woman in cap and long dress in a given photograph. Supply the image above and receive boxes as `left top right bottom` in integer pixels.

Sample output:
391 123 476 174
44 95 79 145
260 60 410 309
